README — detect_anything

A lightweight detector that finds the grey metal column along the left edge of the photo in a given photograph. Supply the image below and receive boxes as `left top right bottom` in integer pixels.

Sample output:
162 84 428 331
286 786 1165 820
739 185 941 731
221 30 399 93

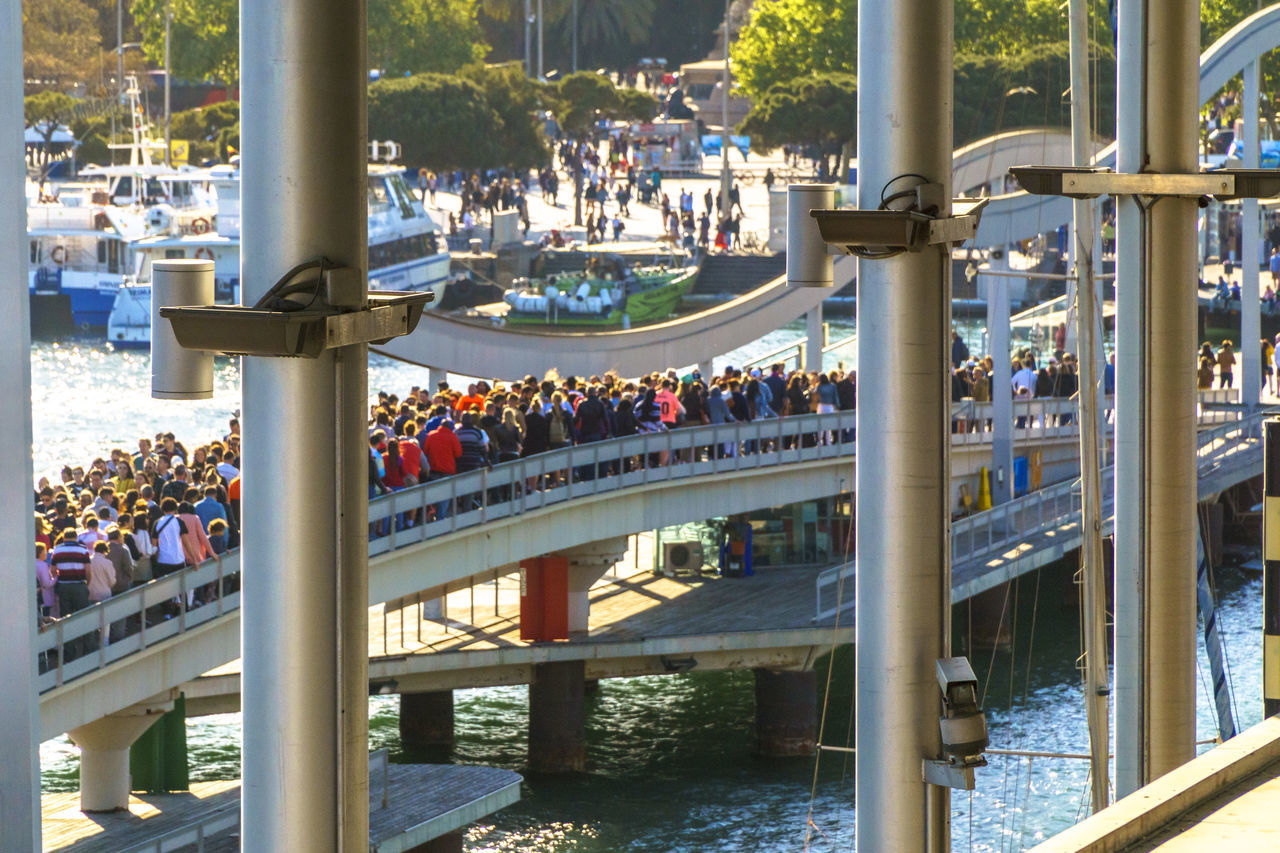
0 0 41 853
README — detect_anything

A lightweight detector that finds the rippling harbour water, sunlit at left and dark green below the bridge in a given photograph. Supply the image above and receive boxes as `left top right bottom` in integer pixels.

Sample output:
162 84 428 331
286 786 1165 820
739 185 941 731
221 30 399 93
32 327 1262 853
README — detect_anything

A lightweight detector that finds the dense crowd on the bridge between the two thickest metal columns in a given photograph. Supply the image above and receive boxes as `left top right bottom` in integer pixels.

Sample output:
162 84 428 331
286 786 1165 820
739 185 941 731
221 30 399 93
369 364 856 527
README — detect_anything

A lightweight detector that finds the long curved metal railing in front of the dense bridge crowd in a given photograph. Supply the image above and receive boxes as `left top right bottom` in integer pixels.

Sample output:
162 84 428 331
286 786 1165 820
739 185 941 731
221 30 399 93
36 411 855 693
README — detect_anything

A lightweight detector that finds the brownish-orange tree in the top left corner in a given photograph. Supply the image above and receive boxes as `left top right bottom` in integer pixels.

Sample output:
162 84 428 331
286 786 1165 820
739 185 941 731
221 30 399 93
22 0 102 88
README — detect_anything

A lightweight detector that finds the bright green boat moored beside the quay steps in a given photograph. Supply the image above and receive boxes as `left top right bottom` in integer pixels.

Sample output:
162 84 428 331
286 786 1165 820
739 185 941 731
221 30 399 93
503 254 698 328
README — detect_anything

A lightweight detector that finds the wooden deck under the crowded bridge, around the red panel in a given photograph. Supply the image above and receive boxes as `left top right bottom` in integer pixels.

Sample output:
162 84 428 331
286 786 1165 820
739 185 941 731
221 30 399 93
183 560 854 701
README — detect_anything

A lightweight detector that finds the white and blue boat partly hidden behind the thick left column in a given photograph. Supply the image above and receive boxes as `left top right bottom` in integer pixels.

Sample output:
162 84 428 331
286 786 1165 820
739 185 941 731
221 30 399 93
106 156 451 348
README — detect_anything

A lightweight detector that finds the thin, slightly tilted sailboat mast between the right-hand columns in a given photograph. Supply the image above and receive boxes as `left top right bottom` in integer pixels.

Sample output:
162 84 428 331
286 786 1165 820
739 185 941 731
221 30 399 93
1069 0 1110 812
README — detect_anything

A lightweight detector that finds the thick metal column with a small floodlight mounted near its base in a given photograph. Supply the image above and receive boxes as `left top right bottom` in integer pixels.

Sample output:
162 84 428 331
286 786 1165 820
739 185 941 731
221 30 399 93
856 0 954 853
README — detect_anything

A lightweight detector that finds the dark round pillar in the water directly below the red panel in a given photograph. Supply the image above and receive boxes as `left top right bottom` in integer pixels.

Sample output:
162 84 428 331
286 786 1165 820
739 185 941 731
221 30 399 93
529 661 586 774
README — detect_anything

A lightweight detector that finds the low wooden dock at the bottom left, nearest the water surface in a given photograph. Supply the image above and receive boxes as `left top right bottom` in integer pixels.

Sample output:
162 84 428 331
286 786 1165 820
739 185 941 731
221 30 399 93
41 765 521 853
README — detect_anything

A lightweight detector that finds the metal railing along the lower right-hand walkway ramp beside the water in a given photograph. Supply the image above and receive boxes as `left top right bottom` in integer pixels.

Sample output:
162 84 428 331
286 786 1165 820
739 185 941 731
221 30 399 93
814 401 1275 620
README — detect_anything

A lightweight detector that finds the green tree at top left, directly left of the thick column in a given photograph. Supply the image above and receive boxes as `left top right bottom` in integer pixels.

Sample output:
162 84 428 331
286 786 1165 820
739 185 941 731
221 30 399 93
132 0 239 88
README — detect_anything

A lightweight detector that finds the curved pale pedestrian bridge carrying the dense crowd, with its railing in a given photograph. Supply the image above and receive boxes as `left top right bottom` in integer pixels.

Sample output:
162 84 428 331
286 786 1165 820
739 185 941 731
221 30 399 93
30 400 1261 739
